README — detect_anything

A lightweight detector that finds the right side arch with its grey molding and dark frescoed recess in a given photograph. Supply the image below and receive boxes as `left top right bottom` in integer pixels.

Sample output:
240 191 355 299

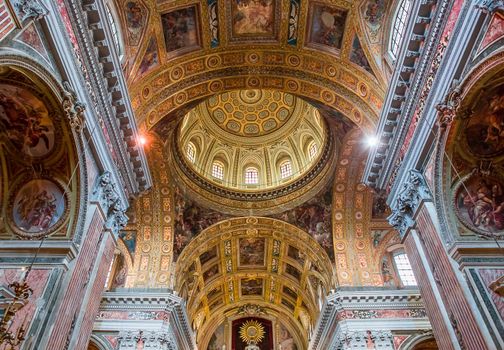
433 51 504 239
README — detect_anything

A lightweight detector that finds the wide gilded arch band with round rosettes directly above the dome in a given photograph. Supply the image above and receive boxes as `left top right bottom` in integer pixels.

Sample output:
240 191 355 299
132 48 384 130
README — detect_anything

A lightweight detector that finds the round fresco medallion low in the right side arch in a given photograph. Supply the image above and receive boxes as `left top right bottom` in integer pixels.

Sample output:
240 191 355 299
455 175 504 234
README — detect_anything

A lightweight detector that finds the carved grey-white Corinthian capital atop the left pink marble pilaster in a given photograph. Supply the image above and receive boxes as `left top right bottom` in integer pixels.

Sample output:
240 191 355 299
93 171 128 235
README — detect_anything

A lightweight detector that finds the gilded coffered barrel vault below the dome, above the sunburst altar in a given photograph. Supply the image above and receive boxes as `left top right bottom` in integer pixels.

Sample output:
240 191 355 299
175 217 334 344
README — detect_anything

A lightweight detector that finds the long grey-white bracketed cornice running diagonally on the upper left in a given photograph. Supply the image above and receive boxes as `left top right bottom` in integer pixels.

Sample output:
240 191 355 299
66 0 152 194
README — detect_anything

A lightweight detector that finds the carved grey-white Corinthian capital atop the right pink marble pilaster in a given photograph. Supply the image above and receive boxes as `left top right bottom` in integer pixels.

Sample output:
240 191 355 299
388 169 432 239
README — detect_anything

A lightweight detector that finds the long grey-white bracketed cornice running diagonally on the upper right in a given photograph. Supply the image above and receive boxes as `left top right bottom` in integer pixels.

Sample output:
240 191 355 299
363 0 453 188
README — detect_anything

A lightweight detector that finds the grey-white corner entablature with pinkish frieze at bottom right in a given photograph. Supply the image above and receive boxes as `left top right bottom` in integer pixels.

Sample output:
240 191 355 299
308 288 430 350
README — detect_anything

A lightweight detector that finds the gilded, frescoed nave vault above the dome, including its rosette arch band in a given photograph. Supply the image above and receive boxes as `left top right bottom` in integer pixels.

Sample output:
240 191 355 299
117 0 388 129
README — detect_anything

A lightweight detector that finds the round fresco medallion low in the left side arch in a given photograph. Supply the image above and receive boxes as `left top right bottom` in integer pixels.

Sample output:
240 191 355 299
12 179 67 236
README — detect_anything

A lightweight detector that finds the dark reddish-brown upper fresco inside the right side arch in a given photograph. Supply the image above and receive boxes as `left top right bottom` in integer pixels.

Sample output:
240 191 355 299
465 86 504 157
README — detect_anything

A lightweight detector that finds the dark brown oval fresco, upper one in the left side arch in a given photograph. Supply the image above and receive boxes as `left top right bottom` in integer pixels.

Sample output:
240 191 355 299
0 84 54 157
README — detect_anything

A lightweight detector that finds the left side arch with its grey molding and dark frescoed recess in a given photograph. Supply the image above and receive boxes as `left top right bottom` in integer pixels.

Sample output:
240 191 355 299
0 54 84 242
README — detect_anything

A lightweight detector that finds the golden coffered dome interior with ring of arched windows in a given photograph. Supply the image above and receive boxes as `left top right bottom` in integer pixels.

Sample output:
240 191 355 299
172 89 334 215
